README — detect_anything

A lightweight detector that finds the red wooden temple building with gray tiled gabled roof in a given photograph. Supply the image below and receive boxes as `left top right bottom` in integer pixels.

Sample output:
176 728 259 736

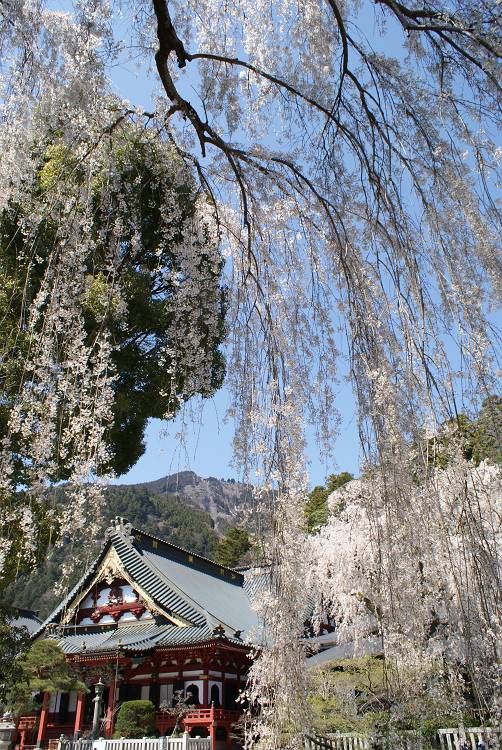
19 519 266 750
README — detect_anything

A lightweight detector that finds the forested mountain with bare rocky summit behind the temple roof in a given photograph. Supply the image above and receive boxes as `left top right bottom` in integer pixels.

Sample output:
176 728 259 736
4 471 251 618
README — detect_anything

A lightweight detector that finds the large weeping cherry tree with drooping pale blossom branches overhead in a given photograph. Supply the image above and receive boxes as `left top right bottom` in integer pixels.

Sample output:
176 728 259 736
0 0 502 748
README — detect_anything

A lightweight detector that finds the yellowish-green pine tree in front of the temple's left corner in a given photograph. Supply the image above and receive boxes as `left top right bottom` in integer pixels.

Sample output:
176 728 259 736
6 639 87 714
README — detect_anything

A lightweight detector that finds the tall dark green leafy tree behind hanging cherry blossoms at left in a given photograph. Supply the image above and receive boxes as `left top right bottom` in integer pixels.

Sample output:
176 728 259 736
0 124 226 586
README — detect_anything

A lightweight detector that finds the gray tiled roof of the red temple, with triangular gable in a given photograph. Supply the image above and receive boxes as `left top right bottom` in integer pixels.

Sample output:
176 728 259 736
35 521 263 653
